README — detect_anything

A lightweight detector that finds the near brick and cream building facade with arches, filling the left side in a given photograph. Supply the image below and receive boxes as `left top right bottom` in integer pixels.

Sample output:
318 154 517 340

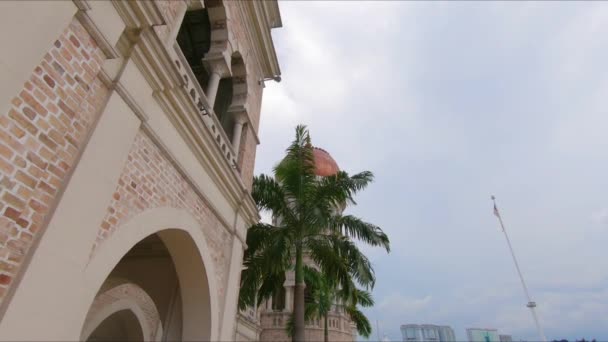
0 0 282 341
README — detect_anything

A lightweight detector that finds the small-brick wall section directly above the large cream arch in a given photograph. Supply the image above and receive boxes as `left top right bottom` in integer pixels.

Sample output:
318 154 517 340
92 131 231 298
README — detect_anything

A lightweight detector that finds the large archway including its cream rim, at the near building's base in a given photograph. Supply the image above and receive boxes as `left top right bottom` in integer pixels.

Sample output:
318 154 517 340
81 208 218 341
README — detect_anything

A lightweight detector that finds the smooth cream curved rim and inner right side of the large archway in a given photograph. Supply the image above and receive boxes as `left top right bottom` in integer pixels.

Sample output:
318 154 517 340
83 207 220 341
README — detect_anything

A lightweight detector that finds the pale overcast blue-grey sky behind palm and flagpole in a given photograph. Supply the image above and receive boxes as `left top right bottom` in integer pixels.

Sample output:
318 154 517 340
252 1 608 340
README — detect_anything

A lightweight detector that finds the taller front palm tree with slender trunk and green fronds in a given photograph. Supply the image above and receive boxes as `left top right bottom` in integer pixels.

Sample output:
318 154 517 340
239 125 390 342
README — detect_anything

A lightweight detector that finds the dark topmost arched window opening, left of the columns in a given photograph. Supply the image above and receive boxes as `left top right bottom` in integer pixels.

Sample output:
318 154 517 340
177 8 211 89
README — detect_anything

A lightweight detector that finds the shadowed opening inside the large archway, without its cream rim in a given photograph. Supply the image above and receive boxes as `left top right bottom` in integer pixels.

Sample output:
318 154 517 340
81 227 212 341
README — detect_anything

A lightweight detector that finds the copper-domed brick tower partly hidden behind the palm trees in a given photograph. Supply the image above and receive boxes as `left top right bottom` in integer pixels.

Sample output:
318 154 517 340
237 148 357 342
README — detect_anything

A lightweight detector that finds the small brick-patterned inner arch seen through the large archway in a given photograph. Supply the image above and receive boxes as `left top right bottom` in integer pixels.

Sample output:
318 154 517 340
84 283 162 341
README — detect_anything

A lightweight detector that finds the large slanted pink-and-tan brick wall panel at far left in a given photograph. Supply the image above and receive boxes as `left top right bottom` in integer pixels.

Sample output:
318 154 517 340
0 20 108 302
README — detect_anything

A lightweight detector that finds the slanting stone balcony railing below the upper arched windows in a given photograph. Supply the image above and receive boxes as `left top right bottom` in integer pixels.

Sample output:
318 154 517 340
173 42 238 170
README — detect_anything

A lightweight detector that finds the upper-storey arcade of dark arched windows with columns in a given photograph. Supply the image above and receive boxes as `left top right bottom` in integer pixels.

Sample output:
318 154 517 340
176 0 248 167
